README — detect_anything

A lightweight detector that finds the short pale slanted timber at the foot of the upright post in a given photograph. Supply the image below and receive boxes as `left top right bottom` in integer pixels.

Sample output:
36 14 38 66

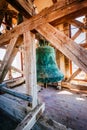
15 103 45 130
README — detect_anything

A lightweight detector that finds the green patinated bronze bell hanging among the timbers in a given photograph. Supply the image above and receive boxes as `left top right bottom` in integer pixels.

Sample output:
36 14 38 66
36 40 64 83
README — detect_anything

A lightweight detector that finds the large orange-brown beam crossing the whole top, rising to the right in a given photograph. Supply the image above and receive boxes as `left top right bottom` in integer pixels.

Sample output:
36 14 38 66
0 0 87 45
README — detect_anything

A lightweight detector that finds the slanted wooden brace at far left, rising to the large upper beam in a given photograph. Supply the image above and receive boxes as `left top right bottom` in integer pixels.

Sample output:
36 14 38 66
0 37 22 82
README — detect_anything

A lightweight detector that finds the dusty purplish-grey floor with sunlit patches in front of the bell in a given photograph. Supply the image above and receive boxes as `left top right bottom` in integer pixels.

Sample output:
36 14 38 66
0 86 87 130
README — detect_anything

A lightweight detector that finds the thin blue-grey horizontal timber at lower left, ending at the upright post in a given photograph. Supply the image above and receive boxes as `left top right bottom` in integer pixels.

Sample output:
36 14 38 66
0 84 32 102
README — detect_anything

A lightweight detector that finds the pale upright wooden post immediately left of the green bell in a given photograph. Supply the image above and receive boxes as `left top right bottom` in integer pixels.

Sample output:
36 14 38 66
24 32 37 109
